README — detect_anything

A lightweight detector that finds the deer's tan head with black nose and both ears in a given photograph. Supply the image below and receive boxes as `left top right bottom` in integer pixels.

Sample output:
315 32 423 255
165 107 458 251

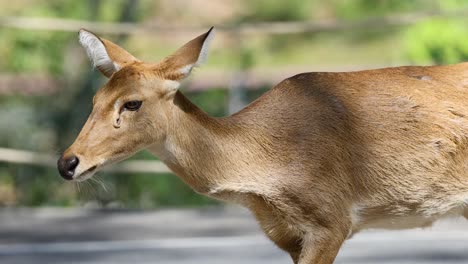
57 28 214 181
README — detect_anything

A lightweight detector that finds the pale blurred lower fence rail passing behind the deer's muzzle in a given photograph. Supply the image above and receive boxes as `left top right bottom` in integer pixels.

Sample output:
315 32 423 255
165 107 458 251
0 148 171 173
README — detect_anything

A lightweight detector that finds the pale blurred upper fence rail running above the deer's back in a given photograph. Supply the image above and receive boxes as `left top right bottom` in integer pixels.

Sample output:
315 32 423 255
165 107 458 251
0 9 468 35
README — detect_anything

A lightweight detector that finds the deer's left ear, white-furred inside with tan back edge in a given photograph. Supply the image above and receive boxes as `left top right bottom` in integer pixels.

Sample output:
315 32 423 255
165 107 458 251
79 29 138 78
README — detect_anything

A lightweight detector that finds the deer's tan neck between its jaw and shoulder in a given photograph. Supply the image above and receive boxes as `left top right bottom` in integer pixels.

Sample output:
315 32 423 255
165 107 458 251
149 92 251 194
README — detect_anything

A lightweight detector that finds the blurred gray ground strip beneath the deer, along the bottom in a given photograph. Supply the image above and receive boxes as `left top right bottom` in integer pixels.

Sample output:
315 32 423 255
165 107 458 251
0 207 468 264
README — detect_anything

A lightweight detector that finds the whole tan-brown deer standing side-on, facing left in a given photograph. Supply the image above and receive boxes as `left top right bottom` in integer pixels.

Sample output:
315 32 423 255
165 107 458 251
58 28 468 264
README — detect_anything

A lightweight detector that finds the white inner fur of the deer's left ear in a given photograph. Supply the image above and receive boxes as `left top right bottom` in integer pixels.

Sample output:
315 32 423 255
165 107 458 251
79 29 121 75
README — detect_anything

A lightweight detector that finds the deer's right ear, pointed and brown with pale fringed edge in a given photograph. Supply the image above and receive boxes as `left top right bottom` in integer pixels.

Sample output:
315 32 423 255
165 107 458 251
157 27 215 81
